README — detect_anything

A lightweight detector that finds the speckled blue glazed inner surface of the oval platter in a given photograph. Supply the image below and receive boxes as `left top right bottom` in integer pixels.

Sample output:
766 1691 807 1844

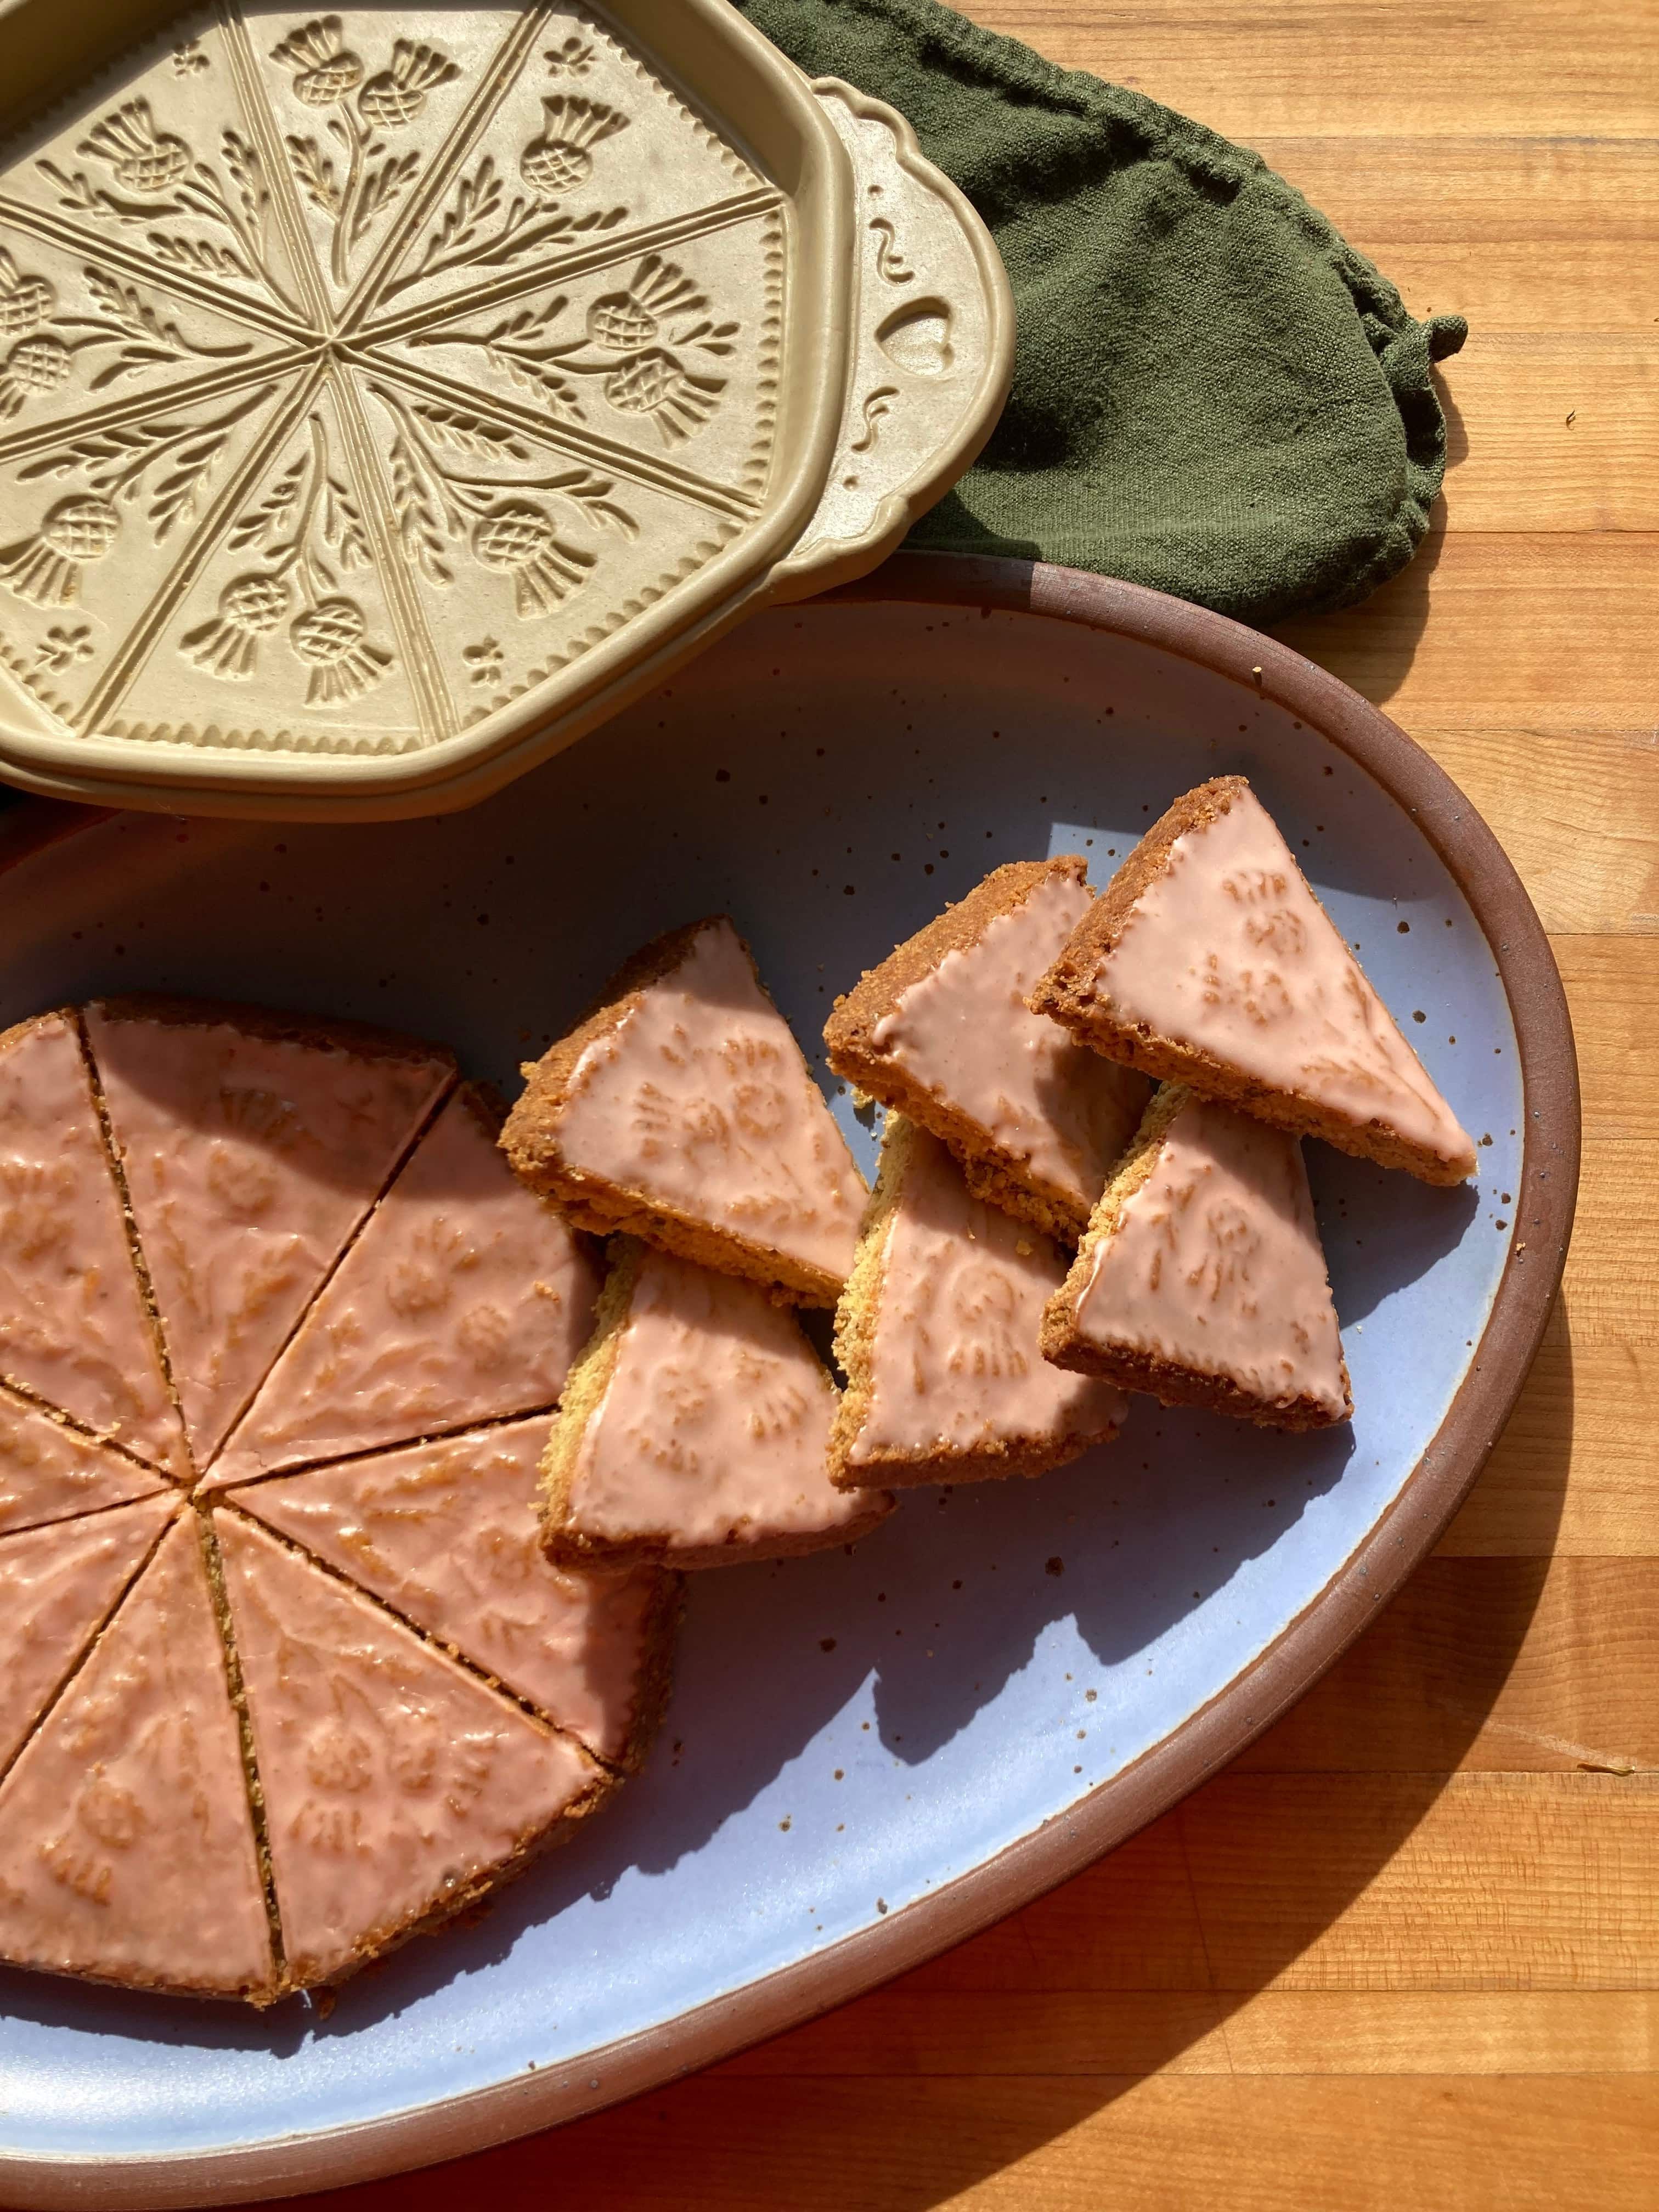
0 604 1522 2159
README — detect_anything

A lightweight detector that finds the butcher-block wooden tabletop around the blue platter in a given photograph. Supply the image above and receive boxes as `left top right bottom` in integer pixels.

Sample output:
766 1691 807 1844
266 0 1659 2212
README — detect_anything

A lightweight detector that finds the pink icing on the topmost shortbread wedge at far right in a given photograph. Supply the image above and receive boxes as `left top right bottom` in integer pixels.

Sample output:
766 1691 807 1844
1093 792 1475 1175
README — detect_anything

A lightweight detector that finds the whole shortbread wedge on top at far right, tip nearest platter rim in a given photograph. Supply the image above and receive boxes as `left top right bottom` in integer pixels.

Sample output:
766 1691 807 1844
1031 776 1475 1183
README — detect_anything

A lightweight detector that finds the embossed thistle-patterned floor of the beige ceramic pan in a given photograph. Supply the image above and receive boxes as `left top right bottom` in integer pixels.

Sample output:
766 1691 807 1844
0 11 776 743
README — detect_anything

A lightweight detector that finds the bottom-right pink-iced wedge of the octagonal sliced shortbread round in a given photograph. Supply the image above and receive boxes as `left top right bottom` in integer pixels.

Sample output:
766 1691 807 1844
212 1509 615 1989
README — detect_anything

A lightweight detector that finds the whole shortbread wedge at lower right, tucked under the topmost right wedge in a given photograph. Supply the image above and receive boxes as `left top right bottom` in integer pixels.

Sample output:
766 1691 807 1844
1042 1084 1354 1429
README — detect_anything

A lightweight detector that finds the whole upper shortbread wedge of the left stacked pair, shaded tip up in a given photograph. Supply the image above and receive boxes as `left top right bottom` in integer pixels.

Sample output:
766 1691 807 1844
502 916 865 1305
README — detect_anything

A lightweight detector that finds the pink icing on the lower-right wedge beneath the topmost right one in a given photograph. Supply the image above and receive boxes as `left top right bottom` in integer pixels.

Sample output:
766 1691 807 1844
1075 1097 1347 1420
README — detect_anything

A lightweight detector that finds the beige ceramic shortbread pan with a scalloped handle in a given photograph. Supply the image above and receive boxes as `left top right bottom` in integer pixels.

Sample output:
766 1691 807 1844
0 0 1013 821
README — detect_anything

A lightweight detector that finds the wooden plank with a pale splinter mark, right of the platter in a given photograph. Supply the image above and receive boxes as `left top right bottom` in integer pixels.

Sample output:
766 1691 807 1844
1232 1558 1659 1774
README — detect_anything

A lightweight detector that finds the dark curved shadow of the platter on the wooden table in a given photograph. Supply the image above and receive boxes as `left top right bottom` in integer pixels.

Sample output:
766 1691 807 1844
269 1305 1573 2212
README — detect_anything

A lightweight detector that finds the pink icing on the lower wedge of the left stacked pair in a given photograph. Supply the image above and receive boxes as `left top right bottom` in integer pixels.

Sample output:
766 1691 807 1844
568 1250 884 1560
